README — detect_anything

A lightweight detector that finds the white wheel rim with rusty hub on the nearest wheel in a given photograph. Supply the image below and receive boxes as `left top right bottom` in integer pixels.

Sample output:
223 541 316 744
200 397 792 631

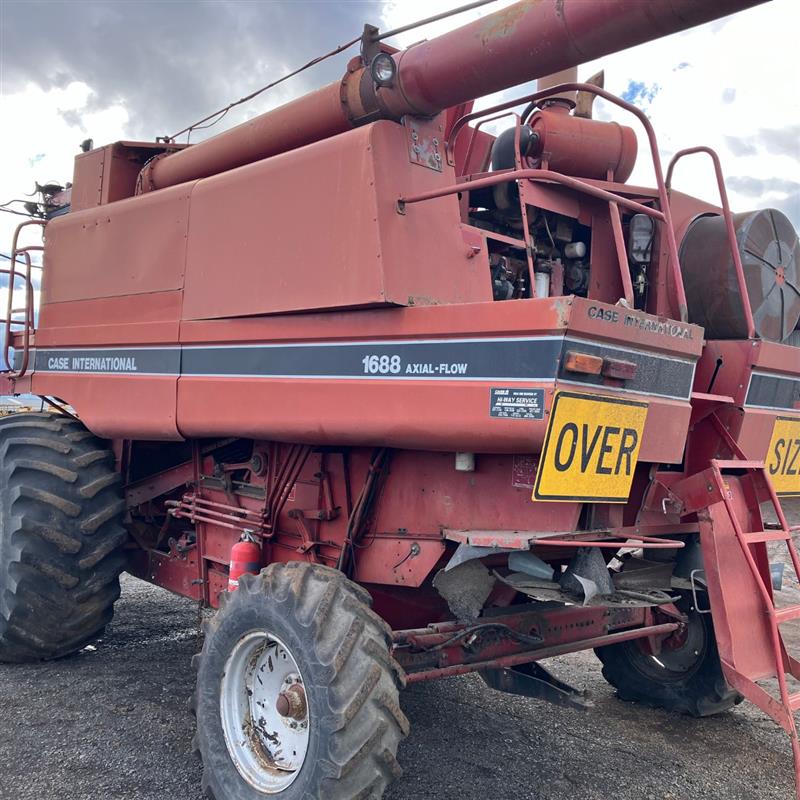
220 631 309 794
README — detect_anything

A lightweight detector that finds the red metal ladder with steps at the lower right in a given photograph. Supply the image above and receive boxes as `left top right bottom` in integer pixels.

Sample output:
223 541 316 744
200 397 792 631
676 459 800 800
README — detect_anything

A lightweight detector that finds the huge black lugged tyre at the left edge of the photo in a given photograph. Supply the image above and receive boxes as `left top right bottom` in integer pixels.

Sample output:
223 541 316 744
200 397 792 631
0 413 127 662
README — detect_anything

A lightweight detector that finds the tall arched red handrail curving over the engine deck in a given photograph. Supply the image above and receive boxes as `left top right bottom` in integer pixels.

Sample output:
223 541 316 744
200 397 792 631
445 83 689 322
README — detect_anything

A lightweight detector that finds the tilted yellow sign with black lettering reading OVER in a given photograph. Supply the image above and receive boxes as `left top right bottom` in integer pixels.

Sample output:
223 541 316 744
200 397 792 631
533 392 647 503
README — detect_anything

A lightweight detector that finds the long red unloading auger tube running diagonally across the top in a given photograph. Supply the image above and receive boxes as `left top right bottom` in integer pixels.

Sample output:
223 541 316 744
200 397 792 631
141 0 764 191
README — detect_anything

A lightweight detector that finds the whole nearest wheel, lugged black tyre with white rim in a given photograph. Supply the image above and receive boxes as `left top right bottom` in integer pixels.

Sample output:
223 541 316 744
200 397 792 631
191 562 408 800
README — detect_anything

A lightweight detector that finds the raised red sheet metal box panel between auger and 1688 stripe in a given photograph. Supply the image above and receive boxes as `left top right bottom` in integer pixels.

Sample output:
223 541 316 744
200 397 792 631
183 122 491 320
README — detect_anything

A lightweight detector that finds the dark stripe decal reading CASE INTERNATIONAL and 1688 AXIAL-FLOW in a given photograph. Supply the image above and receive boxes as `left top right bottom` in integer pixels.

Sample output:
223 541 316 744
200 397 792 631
20 335 694 400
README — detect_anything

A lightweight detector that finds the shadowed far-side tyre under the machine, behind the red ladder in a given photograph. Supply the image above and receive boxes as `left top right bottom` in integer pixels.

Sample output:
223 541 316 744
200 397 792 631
595 597 742 717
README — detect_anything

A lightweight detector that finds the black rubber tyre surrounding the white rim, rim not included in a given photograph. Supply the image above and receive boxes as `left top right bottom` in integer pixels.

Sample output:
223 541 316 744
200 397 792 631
190 561 409 800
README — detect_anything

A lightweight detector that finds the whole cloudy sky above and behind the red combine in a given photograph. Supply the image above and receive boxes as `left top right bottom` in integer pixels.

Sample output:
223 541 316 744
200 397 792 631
0 0 800 268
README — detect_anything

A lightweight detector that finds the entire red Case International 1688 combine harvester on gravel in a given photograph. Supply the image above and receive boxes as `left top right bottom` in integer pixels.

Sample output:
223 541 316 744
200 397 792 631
0 0 800 800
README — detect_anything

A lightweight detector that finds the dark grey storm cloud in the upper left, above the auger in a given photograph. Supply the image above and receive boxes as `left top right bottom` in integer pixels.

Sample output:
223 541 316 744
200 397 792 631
0 0 382 139
